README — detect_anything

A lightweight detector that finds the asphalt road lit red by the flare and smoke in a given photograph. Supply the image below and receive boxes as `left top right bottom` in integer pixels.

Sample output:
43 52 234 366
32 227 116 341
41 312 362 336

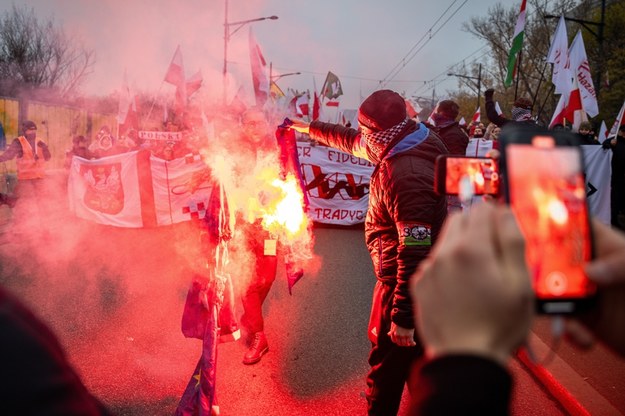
0 201 623 416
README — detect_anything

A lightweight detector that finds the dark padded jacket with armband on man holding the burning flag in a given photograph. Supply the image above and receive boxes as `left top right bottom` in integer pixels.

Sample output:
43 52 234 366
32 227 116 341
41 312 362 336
310 121 448 328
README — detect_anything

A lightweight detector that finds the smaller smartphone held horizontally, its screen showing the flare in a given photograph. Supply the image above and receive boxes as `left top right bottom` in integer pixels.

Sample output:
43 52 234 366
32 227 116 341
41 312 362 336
434 155 499 195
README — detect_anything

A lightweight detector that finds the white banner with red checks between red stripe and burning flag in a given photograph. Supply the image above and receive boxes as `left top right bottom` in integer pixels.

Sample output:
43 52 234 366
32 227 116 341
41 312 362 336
150 155 214 225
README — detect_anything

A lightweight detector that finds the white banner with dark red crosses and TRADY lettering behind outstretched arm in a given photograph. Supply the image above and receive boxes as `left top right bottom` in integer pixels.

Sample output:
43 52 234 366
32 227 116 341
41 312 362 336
297 142 374 225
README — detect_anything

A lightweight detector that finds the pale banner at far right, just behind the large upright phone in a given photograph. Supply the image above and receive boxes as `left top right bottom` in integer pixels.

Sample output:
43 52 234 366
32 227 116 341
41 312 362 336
581 145 612 224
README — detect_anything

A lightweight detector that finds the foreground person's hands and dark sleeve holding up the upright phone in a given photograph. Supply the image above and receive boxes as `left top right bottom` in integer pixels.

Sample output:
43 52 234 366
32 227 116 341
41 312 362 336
409 201 625 415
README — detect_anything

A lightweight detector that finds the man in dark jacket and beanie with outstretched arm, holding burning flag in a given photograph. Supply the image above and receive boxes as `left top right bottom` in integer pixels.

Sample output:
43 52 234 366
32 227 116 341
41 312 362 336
291 90 448 415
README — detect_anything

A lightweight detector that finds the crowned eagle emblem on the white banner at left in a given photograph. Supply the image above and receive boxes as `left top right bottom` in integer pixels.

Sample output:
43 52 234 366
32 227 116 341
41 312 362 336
80 163 124 215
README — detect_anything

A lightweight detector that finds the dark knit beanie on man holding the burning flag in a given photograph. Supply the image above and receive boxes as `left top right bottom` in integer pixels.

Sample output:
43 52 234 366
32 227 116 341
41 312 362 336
358 90 407 131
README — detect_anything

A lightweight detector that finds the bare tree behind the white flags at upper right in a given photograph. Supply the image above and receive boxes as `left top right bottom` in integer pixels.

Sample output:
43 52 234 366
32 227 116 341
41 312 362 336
456 0 625 123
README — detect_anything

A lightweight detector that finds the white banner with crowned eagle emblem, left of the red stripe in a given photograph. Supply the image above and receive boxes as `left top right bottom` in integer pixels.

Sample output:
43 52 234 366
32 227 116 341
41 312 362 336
67 152 143 228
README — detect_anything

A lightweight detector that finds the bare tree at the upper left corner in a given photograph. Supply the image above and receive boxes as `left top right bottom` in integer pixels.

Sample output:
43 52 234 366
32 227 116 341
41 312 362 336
0 5 95 97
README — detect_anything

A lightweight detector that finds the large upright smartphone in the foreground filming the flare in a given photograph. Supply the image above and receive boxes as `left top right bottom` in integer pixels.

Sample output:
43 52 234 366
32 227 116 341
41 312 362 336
500 126 596 314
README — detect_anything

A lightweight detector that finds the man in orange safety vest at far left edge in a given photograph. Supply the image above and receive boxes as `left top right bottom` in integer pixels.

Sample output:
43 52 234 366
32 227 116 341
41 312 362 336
0 120 51 229
